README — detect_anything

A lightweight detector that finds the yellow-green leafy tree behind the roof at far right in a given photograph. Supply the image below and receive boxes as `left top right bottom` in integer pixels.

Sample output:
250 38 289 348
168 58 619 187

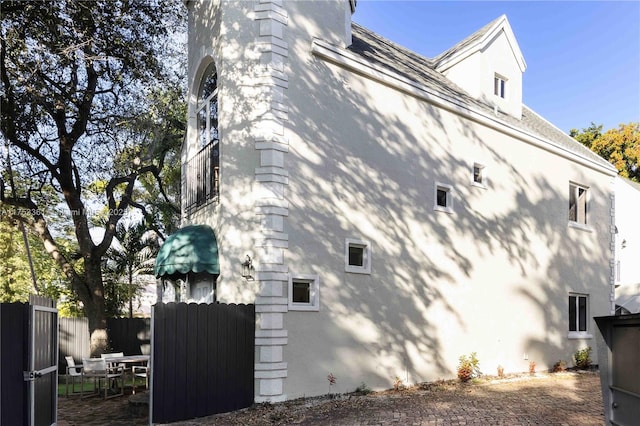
569 122 640 182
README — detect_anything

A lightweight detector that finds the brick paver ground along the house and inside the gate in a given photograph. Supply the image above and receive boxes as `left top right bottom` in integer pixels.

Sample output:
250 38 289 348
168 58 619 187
58 372 604 426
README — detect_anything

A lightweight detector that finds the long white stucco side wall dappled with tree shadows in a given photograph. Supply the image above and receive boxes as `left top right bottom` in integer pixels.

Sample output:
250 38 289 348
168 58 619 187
284 3 612 397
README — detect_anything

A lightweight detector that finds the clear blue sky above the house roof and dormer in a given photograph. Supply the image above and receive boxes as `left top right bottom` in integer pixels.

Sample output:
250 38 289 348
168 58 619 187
353 0 640 133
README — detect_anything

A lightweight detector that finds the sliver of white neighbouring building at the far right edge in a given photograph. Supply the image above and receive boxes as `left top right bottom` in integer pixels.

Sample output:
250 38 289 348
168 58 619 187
615 177 640 314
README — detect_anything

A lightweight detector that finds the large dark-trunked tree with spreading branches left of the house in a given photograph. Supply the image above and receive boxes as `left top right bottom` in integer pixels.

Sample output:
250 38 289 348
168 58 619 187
0 0 183 355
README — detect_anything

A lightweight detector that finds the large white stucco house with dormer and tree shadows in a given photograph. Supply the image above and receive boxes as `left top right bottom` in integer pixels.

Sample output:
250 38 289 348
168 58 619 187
156 0 616 401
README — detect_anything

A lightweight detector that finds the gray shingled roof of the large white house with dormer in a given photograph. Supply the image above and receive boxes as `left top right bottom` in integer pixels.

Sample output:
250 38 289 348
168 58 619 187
349 22 612 168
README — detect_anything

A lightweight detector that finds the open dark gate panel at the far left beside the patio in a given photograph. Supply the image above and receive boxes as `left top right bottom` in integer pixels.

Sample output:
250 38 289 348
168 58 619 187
0 297 58 426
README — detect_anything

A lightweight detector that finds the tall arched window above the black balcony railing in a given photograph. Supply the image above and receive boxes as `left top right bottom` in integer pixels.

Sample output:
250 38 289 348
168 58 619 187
197 62 218 147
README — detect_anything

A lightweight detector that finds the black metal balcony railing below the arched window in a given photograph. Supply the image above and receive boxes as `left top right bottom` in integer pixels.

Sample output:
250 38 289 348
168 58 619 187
186 140 220 214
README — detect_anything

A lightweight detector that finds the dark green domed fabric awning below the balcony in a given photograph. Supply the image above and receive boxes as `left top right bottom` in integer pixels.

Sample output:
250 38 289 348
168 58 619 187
154 225 220 279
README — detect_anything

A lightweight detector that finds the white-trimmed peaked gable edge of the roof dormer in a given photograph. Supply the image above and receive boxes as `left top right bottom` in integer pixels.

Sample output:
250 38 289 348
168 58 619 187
433 15 527 72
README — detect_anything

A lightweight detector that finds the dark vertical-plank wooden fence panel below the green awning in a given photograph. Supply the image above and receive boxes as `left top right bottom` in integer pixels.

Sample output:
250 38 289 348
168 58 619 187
150 303 255 423
